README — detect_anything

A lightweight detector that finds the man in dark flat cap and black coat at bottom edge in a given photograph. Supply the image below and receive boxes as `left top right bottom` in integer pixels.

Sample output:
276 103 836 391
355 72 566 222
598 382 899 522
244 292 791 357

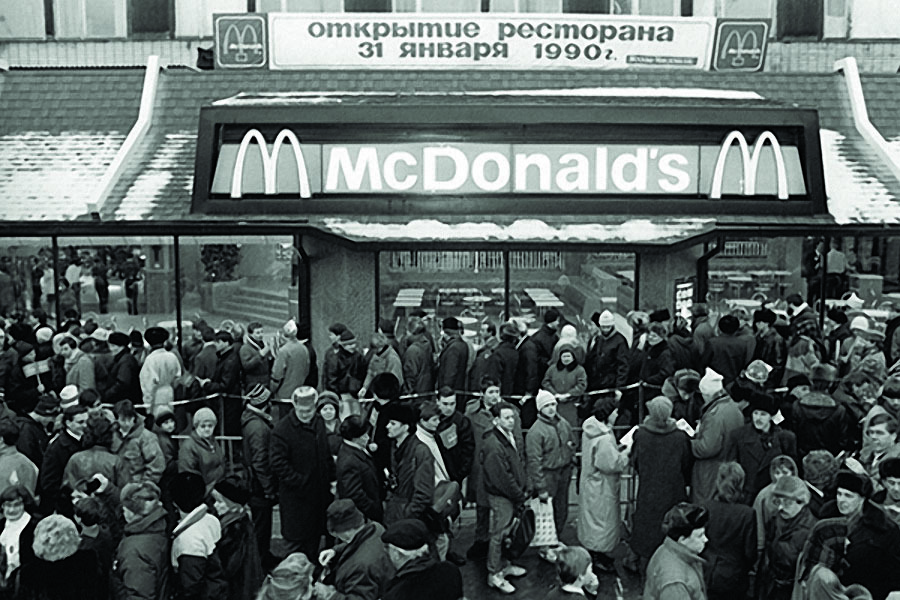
381 519 463 600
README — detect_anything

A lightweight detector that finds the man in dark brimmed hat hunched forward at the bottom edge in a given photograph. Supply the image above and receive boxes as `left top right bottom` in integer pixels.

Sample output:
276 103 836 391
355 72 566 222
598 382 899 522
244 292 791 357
315 499 394 600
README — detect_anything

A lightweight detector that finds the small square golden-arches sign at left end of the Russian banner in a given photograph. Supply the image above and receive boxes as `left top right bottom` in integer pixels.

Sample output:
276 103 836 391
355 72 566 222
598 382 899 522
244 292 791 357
213 14 269 69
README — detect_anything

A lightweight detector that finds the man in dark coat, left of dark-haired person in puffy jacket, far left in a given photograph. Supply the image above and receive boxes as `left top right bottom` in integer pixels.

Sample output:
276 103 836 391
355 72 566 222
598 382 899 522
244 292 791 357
38 404 88 515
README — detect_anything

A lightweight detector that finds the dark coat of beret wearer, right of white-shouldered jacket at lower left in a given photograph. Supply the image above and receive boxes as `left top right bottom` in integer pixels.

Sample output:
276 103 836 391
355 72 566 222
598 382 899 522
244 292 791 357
216 512 265 600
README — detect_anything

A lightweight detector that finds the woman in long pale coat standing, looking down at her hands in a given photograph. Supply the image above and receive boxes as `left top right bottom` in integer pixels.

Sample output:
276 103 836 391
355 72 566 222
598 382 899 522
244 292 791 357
578 395 629 571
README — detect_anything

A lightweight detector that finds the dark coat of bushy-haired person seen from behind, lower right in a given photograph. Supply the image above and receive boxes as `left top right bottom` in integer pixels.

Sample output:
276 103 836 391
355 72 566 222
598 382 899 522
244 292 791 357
702 500 756 597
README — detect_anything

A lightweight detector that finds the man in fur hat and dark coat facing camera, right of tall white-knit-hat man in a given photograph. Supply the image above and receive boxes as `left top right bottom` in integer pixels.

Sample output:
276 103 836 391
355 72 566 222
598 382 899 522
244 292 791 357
725 393 799 504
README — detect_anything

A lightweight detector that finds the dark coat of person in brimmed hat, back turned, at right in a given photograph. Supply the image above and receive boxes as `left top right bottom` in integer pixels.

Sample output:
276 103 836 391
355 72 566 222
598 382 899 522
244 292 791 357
791 392 849 456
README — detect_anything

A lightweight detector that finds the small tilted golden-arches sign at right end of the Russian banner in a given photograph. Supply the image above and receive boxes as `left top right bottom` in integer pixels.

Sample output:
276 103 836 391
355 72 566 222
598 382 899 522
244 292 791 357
710 19 770 73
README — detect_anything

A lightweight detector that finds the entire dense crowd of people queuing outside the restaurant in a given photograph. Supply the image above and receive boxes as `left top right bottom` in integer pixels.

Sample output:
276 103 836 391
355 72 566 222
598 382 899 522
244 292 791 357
0 294 900 600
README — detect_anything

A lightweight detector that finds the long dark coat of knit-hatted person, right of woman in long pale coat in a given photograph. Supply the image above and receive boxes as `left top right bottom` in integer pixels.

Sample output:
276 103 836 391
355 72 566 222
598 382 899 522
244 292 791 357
630 419 694 558
